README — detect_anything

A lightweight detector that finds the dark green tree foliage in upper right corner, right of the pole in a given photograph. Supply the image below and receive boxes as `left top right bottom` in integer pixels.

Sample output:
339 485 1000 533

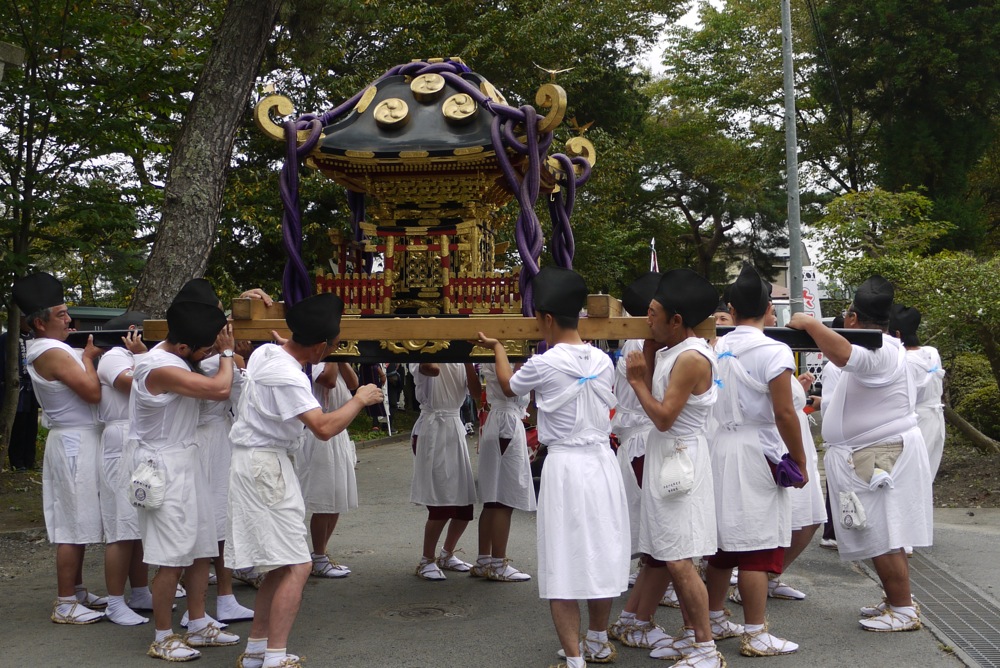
818 0 1000 248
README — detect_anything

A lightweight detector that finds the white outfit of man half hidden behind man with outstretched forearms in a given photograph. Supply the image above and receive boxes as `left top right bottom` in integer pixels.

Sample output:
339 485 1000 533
295 363 358 514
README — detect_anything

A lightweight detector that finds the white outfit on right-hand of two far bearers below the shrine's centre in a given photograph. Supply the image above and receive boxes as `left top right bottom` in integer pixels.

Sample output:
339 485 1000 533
479 364 536 512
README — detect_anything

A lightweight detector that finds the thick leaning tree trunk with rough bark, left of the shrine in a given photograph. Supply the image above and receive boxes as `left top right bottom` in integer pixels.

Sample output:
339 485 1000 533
131 0 281 317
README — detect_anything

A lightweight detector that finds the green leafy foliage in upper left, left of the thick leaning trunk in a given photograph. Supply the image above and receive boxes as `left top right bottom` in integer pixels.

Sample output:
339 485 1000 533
0 0 214 305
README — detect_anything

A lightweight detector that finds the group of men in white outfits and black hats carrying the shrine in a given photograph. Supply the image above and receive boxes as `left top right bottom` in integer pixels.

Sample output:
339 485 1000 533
13 266 944 668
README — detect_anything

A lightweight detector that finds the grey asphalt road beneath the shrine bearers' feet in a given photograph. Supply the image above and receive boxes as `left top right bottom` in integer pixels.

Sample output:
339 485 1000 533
0 440 984 668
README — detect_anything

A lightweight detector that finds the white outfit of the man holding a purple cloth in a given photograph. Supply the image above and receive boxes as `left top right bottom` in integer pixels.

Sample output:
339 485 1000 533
711 325 795 552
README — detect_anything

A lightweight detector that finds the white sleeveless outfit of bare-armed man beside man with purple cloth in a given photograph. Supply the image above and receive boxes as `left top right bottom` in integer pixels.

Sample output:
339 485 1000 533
639 337 718 561
